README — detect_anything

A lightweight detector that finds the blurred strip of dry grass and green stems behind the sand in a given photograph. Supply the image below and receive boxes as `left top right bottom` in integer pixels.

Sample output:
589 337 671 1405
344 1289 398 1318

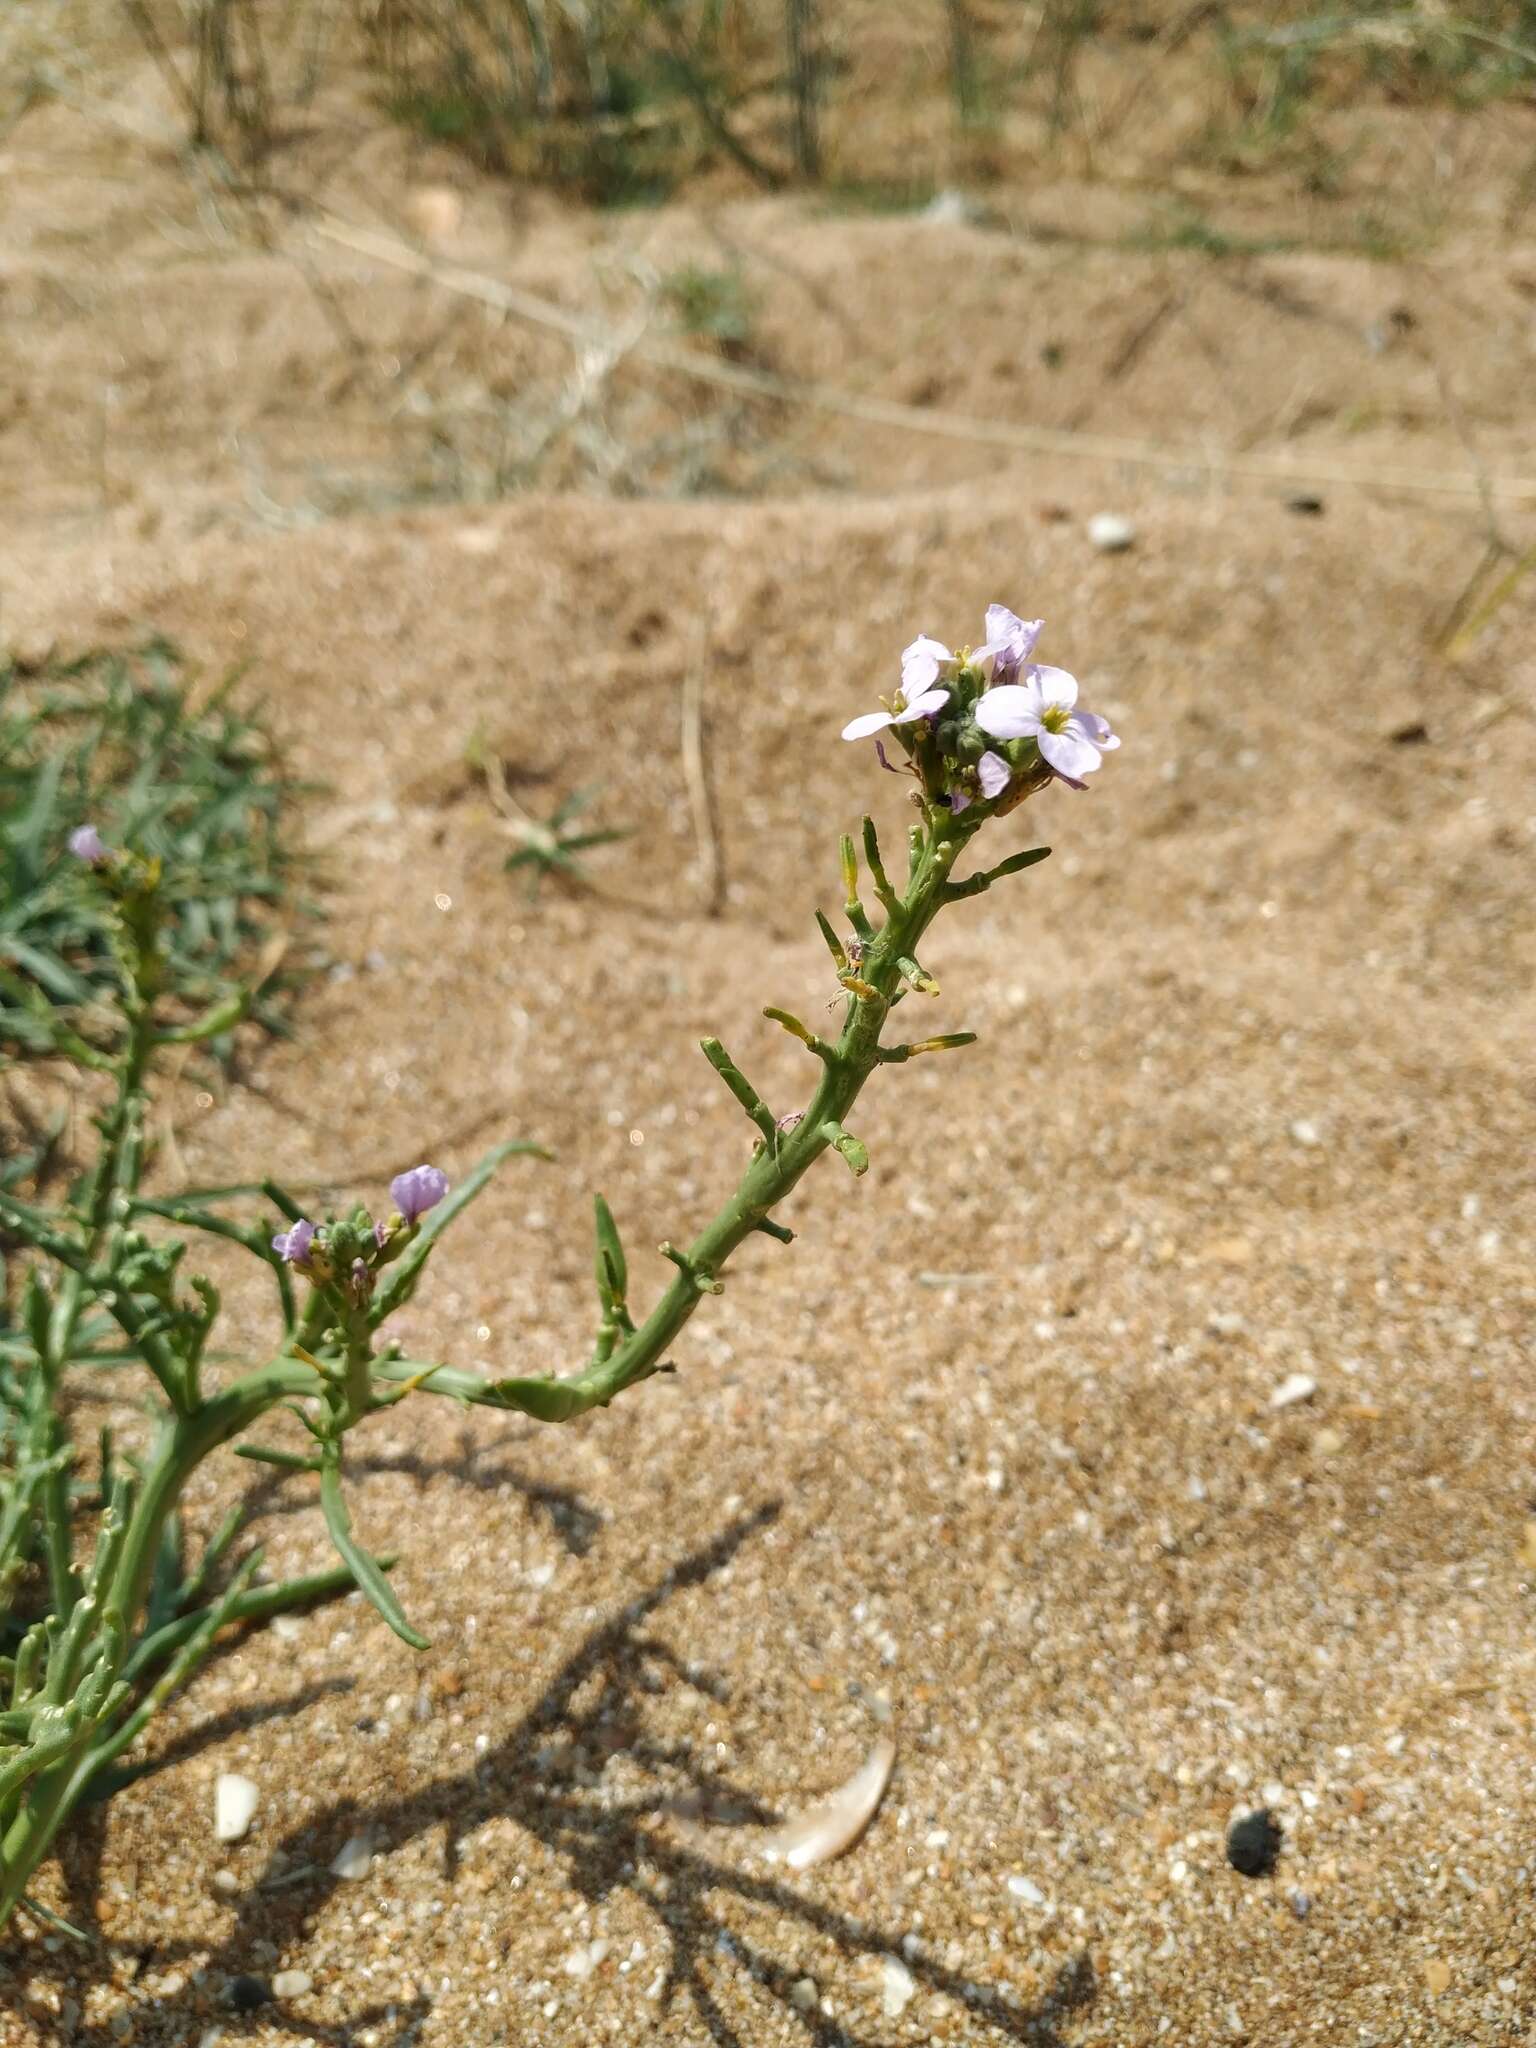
0 0 1536 205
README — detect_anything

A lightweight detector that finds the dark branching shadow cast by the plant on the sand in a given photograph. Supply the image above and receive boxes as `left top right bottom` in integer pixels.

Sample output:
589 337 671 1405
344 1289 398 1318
18 1503 1096 2048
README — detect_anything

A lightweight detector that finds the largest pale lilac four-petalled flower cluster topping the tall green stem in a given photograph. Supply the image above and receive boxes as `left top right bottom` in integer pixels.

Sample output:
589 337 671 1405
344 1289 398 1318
842 604 1120 811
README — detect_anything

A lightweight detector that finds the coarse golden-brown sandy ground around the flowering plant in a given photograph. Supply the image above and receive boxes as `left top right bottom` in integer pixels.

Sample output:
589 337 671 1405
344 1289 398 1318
0 16 1536 2048
